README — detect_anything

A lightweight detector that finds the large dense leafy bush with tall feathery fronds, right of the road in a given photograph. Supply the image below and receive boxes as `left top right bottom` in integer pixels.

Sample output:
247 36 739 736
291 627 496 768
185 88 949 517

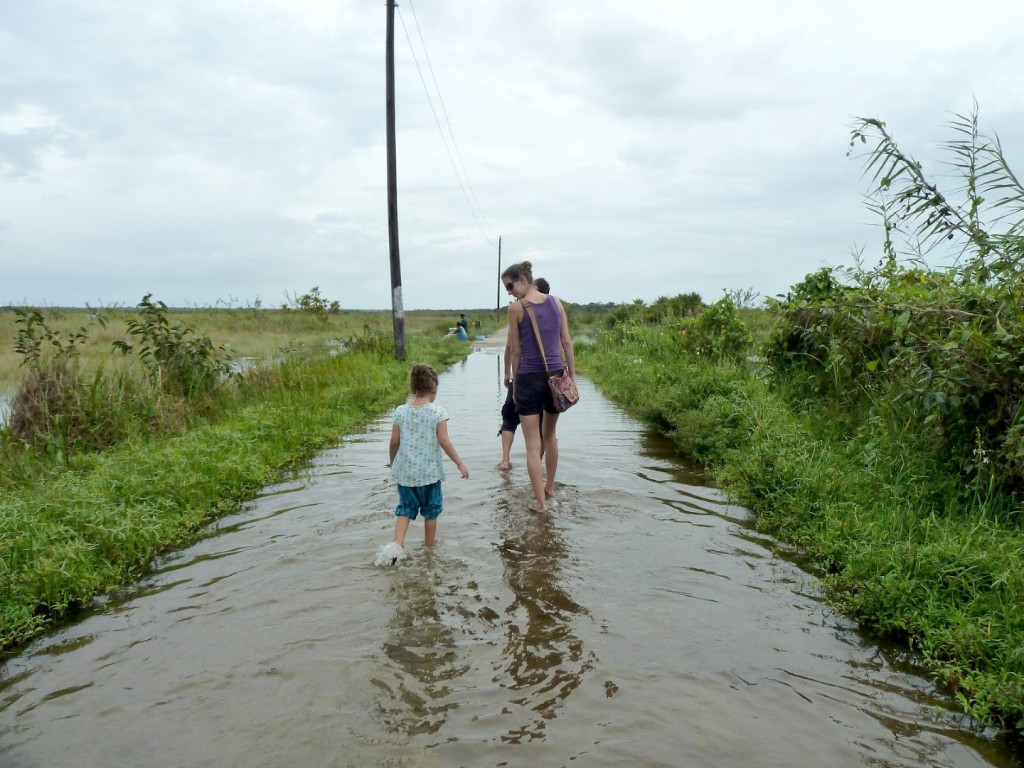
763 114 1024 494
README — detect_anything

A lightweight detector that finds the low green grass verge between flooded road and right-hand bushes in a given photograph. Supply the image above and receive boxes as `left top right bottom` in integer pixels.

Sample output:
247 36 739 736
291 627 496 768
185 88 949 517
577 313 1024 735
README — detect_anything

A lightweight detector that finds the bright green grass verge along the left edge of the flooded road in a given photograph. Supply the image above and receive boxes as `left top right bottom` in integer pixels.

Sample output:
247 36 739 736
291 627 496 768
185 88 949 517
0 336 470 648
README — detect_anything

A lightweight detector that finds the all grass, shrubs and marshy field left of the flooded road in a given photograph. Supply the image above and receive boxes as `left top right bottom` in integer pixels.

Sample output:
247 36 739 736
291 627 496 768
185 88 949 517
0 296 498 649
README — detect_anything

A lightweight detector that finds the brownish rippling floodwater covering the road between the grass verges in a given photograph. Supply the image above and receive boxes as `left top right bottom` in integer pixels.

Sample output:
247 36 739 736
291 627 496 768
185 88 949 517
0 350 1015 768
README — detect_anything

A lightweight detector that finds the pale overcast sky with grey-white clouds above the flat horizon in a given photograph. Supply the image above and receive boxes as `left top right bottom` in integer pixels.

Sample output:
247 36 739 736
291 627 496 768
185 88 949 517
0 0 1024 309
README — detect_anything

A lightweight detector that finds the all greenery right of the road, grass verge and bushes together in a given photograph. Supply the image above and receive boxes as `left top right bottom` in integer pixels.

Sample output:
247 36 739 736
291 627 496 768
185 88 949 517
578 108 1024 738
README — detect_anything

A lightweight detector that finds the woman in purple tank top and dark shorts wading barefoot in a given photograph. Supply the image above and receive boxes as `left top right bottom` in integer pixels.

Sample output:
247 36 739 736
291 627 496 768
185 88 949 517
502 261 575 512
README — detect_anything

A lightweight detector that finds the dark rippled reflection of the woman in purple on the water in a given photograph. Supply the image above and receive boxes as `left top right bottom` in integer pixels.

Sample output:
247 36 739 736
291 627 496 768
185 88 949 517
494 500 597 743
